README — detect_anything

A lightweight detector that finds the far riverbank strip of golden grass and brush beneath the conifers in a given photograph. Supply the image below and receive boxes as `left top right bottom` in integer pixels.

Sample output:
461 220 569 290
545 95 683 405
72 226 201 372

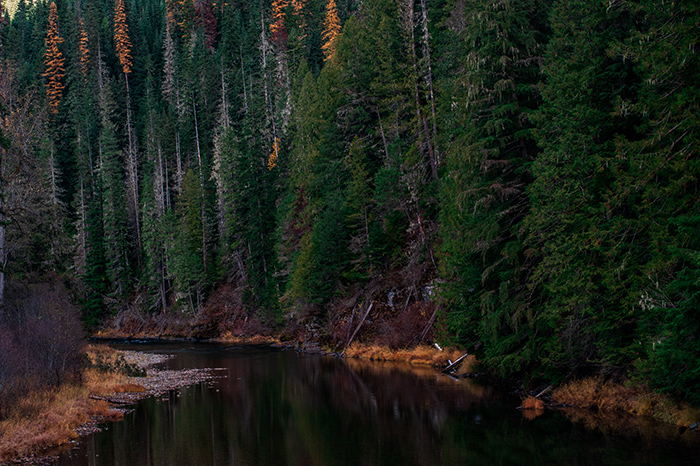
93 313 700 430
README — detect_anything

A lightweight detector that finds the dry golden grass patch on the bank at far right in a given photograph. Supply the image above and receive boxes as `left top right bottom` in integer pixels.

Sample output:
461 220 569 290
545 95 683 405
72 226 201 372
552 377 700 426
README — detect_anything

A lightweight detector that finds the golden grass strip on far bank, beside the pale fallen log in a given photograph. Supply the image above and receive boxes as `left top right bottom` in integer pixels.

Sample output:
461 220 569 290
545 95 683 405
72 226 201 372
345 343 476 374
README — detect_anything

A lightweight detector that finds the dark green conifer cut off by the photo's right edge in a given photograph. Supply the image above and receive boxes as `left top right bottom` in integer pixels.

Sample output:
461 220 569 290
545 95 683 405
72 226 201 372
613 1 700 404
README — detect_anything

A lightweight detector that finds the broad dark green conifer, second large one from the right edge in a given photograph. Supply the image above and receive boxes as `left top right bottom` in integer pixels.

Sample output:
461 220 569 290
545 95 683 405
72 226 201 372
523 0 645 371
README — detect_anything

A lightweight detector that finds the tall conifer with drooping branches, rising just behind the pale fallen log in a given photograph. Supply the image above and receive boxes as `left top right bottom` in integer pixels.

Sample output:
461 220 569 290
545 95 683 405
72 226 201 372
440 0 549 373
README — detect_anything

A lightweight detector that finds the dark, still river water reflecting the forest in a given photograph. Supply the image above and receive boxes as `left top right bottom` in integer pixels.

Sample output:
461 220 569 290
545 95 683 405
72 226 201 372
58 343 700 466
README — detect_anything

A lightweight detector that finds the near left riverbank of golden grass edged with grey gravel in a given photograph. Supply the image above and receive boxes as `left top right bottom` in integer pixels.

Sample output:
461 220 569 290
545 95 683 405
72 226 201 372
0 345 216 464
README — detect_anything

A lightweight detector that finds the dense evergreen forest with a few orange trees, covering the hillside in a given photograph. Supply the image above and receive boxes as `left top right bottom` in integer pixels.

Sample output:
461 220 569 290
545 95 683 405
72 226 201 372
0 0 700 404
